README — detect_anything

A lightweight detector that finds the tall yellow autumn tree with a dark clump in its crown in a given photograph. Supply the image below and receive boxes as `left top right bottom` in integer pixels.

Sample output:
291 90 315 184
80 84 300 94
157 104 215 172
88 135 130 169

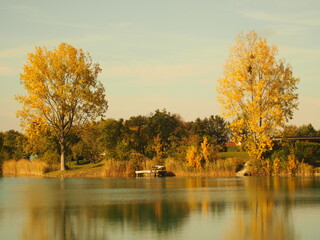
217 31 299 160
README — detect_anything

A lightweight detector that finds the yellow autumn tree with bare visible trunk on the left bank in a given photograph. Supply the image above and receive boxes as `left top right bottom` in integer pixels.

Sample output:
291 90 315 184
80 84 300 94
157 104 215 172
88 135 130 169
16 43 108 170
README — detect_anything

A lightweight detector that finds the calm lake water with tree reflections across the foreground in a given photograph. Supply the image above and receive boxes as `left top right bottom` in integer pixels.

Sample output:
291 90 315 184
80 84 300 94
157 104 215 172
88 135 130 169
0 177 320 240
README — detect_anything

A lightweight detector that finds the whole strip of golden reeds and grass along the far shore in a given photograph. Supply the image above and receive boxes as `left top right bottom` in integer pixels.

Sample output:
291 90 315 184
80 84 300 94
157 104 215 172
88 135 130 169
2 154 314 178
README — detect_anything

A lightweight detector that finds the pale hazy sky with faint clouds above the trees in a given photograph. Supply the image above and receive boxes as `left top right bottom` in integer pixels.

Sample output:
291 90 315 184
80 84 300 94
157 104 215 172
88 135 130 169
0 0 320 131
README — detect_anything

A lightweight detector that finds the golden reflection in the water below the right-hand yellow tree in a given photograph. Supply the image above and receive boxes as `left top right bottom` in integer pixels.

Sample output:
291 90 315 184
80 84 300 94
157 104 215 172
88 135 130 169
225 177 312 240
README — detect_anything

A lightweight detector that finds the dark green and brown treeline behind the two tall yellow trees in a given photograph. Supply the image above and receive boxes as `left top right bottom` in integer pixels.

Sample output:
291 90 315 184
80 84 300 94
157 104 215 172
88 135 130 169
0 110 320 171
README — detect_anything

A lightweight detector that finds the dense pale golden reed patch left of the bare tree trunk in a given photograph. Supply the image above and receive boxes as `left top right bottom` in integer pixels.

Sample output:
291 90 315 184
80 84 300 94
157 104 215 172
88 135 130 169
2 159 50 176
